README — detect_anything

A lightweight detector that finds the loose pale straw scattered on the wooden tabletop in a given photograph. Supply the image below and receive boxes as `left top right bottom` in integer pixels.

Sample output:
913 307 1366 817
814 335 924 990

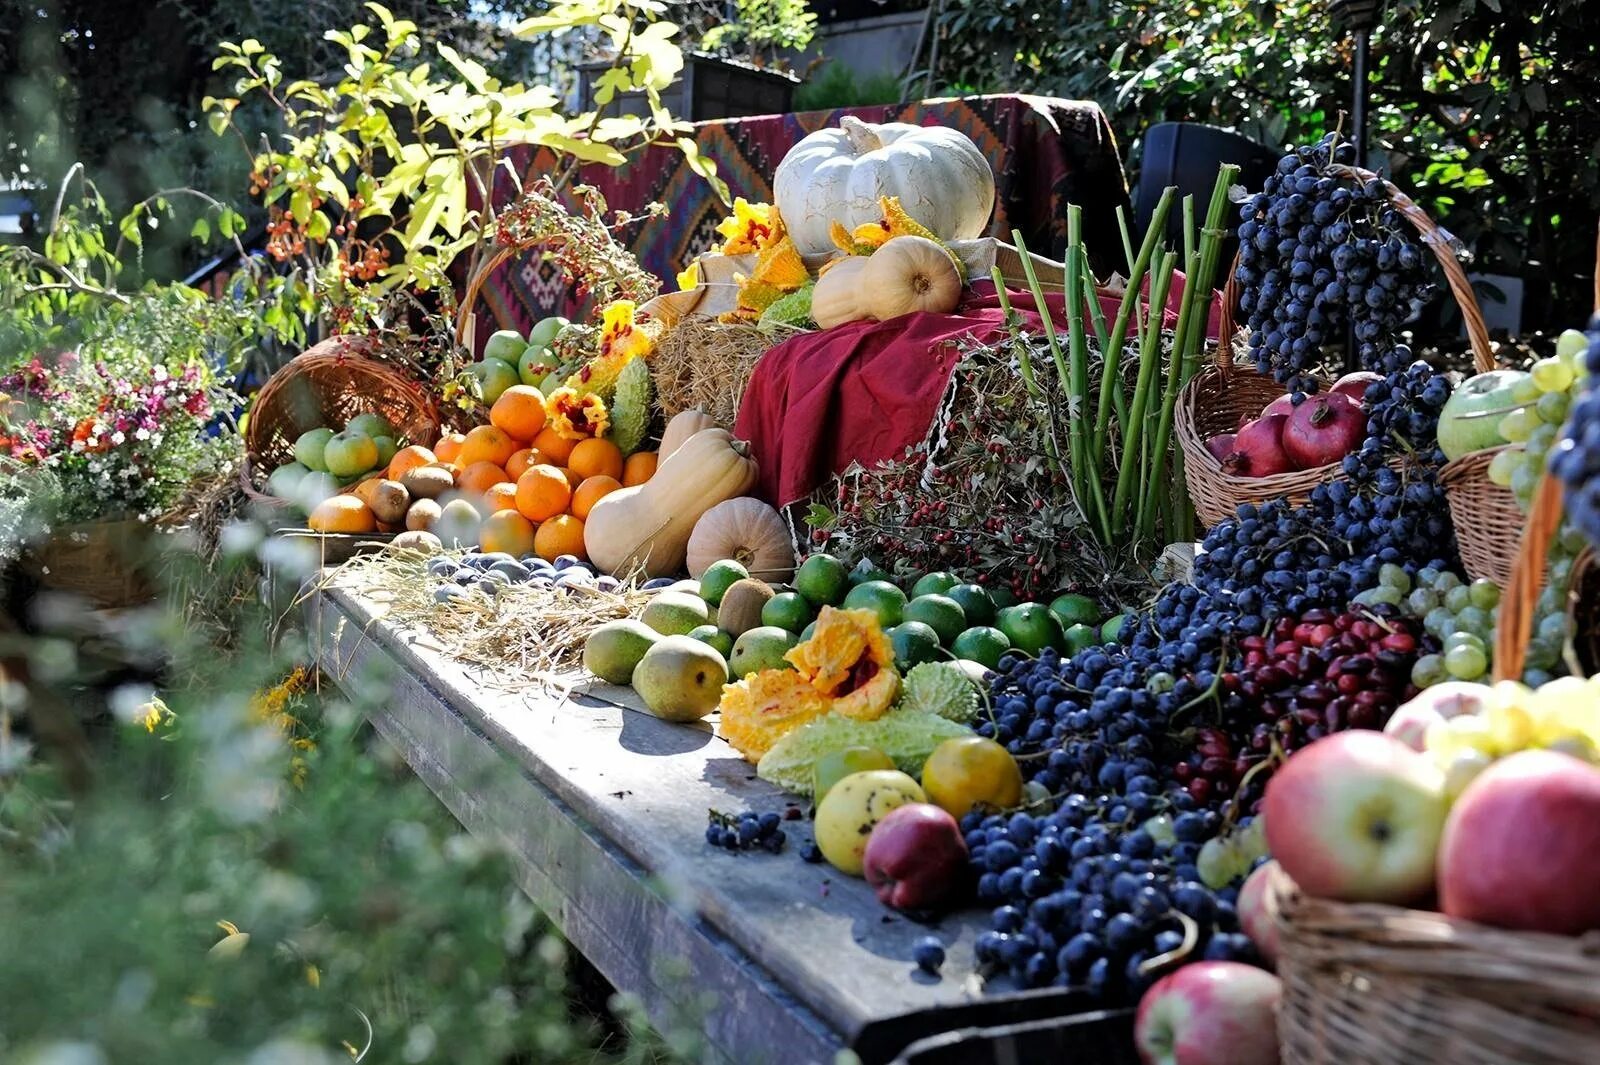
322 550 656 692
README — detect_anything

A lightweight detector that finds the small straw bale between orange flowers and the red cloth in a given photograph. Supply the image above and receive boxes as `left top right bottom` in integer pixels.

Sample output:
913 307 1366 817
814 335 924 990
650 315 805 425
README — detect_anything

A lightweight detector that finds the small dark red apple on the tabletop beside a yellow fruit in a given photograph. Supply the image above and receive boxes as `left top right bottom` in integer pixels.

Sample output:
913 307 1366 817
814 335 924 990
862 803 970 910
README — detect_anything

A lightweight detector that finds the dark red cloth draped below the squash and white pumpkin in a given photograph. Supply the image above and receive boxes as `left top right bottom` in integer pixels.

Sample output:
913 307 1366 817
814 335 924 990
734 275 1221 507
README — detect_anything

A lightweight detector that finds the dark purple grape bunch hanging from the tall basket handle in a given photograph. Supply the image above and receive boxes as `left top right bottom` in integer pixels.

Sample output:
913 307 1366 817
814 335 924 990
1235 133 1429 392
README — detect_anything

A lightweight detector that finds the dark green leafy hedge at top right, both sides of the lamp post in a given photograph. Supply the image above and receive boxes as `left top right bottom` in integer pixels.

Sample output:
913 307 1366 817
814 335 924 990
936 0 1600 321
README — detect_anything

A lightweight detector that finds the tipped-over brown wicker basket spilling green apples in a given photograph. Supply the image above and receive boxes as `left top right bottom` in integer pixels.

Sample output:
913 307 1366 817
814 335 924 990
242 336 438 505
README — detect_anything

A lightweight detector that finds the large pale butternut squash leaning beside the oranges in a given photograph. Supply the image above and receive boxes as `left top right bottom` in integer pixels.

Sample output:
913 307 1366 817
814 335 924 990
584 429 755 577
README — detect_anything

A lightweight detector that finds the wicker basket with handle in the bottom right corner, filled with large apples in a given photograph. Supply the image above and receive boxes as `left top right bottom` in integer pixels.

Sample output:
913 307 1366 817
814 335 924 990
1274 477 1600 1065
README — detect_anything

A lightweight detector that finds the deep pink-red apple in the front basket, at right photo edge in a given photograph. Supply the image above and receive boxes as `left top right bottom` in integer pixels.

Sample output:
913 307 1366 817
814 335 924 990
1438 750 1600 935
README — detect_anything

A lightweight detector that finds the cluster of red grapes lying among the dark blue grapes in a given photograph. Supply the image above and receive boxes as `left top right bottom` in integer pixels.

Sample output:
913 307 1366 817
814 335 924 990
1173 608 1426 803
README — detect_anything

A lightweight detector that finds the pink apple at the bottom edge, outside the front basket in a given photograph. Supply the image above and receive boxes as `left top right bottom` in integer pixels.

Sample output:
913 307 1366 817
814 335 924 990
1133 961 1283 1065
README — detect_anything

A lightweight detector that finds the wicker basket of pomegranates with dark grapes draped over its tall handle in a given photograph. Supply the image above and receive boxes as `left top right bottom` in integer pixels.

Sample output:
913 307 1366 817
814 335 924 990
1173 166 1515 527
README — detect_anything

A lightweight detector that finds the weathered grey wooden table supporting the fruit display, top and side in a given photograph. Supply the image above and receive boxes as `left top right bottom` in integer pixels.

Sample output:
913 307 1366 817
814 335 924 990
307 574 1082 1065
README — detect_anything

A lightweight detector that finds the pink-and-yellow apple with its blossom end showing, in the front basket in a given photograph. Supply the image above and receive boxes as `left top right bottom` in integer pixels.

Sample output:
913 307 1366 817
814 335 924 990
1262 729 1450 905
